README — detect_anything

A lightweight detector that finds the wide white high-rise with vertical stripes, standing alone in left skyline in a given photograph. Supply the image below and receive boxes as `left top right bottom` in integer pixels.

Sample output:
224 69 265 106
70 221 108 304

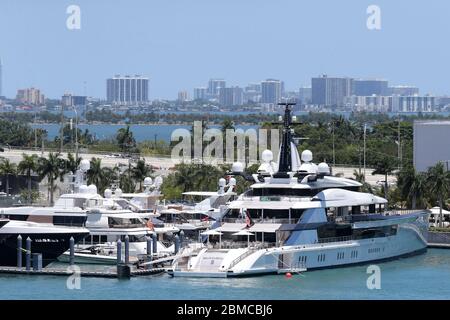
106 75 148 105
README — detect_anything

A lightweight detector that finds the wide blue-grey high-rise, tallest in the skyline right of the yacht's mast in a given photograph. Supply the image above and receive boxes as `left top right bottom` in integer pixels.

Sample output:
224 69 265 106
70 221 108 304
311 75 353 106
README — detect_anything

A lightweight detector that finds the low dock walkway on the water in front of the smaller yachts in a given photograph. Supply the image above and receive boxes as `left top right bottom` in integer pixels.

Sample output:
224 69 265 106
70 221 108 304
0 267 166 278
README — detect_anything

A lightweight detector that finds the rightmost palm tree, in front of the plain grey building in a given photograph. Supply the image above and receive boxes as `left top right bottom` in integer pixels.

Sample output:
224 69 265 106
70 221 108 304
427 162 450 228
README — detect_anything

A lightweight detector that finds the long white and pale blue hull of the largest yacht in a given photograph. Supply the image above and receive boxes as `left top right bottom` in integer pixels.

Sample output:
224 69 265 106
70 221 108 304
169 218 427 277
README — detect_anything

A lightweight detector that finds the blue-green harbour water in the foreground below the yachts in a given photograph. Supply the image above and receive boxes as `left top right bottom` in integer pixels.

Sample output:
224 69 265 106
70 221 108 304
0 249 450 300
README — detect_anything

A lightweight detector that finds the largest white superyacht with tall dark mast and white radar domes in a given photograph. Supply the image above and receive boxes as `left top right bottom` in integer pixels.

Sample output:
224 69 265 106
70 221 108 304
169 103 429 277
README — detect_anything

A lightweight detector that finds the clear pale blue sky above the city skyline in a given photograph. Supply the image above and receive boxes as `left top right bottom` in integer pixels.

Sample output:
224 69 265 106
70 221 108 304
0 0 450 99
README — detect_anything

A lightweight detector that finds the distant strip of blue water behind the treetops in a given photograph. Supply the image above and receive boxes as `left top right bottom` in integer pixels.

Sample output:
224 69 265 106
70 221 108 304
31 123 258 142
